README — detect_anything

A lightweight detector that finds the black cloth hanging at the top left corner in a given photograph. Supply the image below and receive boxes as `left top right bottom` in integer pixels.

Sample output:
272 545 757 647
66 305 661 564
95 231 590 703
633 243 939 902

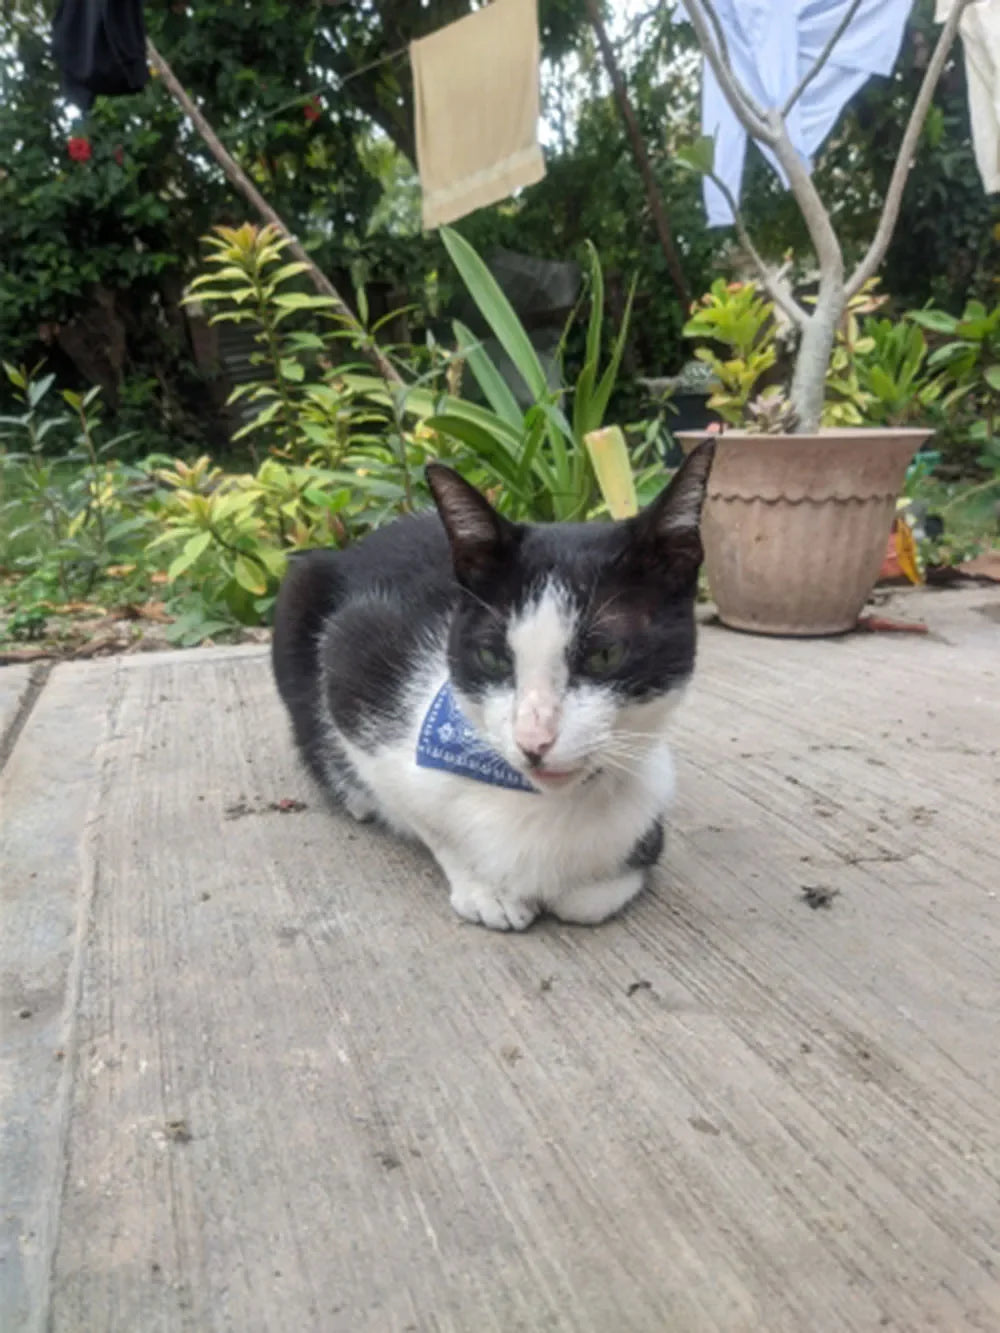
52 0 149 111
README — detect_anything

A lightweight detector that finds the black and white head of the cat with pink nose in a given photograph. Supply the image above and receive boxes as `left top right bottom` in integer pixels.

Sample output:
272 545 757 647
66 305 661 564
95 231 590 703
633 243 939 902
428 443 713 790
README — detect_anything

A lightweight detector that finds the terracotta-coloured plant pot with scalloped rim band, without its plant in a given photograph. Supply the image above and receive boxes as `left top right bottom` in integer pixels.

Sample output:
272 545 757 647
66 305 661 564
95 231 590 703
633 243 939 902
677 428 931 635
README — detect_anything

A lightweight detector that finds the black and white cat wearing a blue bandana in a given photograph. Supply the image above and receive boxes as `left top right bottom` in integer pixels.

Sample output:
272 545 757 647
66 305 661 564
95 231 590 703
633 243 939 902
273 444 713 930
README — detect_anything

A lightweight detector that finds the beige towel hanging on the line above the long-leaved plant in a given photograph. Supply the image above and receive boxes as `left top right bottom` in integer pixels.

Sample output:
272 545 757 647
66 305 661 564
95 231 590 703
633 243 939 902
409 0 545 228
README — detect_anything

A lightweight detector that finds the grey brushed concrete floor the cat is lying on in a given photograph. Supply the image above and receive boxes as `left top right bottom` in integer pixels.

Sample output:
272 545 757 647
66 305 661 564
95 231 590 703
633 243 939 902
0 588 1000 1333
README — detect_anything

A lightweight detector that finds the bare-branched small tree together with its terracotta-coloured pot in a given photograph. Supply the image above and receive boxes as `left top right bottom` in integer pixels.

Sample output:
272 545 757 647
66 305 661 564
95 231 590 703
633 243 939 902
669 0 969 635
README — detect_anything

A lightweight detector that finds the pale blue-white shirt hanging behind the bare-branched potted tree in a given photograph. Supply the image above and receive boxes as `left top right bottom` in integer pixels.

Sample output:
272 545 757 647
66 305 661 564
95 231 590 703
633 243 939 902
701 0 917 227
